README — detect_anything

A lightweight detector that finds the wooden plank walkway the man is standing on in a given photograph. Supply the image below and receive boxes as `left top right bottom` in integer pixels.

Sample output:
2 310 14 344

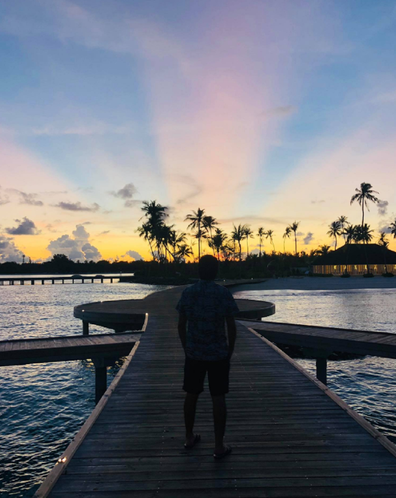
35 288 396 498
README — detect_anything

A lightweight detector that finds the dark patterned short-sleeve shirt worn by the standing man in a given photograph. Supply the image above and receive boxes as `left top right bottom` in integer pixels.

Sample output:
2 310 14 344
176 280 239 361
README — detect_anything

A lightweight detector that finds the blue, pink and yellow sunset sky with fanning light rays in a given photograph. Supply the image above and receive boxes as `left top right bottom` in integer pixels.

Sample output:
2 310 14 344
0 0 396 262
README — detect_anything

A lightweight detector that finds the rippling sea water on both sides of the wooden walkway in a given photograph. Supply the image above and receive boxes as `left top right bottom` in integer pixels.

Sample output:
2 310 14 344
0 283 396 497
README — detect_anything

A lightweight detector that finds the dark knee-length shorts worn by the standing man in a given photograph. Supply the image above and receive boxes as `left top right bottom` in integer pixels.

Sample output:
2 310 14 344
183 356 230 396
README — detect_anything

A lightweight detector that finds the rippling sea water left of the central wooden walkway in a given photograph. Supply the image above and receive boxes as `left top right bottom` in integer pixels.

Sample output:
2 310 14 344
0 283 166 498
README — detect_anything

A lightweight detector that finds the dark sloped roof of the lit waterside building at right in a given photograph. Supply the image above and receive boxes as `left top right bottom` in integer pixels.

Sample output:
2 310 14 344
312 244 396 265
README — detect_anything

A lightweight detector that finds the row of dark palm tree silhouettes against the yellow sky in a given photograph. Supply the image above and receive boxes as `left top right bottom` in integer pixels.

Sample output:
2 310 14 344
137 183 396 262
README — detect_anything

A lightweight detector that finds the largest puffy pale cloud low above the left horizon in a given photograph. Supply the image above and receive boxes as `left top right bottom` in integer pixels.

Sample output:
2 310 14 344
47 225 102 261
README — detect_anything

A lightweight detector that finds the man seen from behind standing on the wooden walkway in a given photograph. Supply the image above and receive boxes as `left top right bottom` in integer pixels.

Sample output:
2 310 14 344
176 255 238 459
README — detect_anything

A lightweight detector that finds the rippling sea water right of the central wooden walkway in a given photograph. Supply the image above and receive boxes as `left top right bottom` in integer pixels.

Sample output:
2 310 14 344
234 279 396 442
